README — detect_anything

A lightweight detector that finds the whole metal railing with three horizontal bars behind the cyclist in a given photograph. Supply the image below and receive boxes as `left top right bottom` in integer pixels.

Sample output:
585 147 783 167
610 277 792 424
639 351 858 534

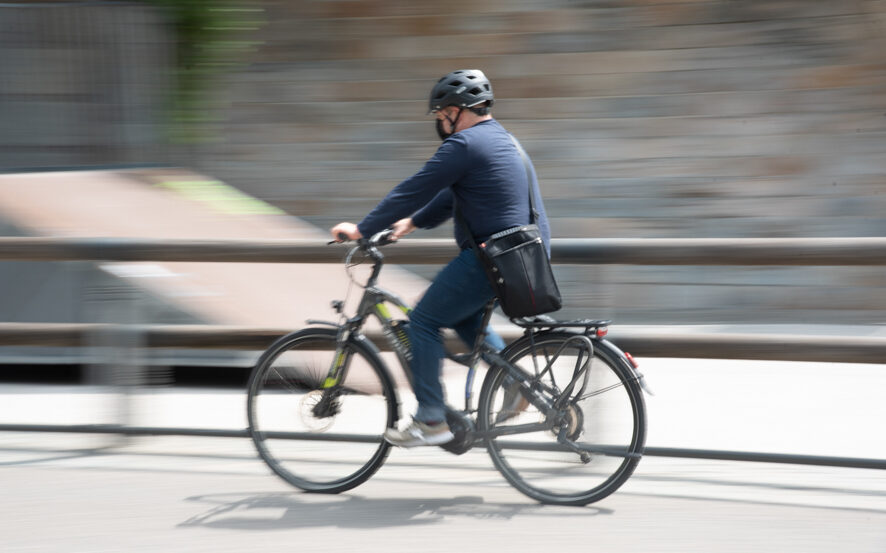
0 234 886 469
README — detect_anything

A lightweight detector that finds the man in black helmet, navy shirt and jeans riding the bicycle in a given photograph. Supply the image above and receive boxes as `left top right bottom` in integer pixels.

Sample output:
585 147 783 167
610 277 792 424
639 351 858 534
331 69 550 447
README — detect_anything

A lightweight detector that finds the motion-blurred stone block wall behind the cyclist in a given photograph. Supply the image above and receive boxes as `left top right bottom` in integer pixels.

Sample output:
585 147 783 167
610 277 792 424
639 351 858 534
196 0 886 324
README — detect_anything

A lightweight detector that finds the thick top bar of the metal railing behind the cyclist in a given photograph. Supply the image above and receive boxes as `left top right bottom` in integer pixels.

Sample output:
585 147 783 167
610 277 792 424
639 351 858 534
0 237 886 266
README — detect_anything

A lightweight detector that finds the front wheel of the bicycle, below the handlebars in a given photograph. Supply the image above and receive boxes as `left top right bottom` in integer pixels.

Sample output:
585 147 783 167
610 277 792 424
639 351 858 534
247 328 399 493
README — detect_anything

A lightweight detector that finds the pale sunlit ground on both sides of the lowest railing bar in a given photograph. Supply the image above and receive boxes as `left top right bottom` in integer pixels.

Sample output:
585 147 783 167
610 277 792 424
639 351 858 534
0 360 886 553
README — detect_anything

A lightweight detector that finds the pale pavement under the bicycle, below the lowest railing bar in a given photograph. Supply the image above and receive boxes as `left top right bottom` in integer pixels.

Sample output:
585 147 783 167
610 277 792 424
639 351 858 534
0 436 886 553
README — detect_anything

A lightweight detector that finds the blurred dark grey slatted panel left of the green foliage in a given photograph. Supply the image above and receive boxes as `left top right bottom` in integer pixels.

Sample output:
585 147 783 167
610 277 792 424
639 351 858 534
0 2 174 171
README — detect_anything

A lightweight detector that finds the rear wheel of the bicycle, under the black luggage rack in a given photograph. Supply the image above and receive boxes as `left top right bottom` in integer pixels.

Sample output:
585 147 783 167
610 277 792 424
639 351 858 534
478 331 646 505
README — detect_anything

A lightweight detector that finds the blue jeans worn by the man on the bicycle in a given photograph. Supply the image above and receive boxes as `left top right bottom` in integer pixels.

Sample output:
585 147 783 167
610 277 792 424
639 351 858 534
409 249 505 422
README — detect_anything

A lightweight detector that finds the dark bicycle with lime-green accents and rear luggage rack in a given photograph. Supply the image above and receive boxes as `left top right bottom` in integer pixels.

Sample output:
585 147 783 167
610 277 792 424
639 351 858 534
247 230 646 505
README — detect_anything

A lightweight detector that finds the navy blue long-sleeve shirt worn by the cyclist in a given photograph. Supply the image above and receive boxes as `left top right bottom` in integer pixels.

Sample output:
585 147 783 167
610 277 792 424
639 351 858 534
357 119 551 249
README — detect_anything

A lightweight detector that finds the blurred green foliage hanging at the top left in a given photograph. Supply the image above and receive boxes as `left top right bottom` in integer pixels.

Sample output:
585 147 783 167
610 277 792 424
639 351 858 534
143 0 264 144
